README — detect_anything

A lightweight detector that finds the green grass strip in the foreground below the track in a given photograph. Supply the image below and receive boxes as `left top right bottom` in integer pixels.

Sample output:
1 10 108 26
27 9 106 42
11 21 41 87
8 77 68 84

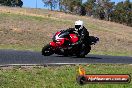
0 64 132 88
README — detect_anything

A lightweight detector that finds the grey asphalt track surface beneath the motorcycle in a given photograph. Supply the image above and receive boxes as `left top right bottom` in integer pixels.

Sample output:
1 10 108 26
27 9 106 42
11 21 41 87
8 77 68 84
0 50 132 66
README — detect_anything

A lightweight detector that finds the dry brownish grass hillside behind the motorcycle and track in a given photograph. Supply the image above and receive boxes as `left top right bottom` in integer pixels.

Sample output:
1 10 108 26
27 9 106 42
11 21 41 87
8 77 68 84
0 7 132 56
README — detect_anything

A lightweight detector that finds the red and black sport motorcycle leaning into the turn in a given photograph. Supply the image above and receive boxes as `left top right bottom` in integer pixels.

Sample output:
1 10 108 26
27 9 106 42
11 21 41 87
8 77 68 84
42 30 99 57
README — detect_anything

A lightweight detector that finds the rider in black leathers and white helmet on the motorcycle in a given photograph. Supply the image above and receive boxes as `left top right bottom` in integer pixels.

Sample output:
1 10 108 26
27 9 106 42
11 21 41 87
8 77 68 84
69 20 91 57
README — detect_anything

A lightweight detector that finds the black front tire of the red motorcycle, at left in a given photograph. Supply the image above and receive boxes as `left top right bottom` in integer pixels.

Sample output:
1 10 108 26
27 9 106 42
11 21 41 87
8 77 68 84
42 44 54 56
